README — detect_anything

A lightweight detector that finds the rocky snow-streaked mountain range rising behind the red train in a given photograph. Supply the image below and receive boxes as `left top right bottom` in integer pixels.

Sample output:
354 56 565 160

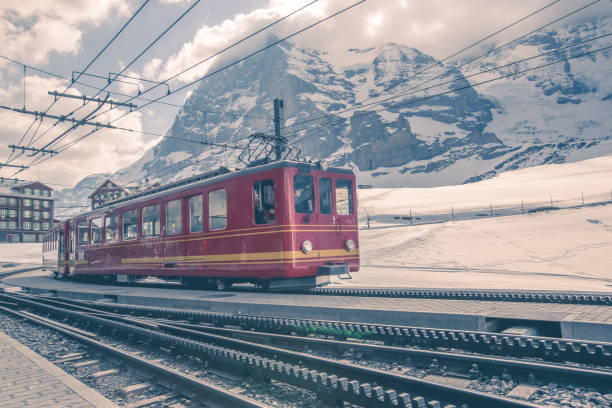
58 18 612 214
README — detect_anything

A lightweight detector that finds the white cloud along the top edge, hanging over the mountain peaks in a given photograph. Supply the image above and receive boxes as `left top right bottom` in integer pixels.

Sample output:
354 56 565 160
150 0 607 82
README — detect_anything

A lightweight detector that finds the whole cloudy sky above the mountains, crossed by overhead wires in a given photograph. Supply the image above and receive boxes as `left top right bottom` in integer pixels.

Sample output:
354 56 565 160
0 0 611 189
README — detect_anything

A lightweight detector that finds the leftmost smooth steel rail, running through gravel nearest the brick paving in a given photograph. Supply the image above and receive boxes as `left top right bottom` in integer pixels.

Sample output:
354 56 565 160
0 306 267 408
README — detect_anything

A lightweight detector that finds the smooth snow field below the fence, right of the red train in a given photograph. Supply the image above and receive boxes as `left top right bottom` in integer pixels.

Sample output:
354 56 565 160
337 204 612 292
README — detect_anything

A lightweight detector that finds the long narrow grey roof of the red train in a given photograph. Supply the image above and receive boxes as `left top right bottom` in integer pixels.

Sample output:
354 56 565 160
65 160 353 219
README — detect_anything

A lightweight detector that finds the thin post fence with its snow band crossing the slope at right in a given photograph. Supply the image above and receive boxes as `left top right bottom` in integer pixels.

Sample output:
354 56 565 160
359 190 612 229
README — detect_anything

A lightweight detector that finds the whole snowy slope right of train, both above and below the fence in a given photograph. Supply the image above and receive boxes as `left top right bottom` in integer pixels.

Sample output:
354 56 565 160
337 156 612 292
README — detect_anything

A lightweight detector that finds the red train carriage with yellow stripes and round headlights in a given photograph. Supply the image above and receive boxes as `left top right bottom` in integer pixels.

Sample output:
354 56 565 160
43 161 359 289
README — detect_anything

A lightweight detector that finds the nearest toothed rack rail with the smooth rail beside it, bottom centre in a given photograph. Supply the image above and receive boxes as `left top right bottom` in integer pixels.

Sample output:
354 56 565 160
0 295 537 408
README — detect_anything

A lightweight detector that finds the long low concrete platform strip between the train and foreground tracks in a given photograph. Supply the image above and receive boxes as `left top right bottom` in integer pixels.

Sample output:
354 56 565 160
2 271 612 342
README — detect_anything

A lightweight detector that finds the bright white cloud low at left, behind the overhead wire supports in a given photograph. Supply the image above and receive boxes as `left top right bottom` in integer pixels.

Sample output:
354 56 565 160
0 76 151 184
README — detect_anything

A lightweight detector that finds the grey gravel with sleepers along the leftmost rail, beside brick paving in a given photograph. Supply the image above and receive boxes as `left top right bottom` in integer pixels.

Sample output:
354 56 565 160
0 312 321 408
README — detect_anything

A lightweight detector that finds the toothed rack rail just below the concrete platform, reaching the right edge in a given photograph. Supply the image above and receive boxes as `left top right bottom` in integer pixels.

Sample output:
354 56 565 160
38 299 612 367
